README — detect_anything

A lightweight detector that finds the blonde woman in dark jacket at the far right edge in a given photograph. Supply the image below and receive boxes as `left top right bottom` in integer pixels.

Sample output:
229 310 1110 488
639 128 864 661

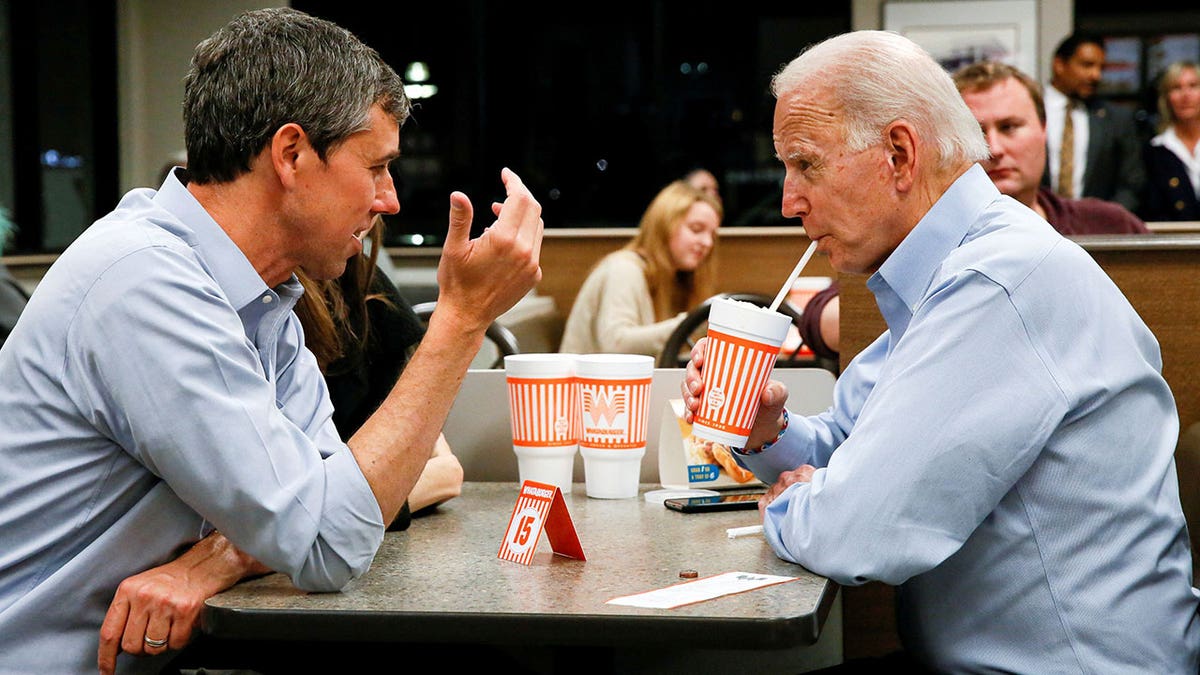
1142 61 1200 221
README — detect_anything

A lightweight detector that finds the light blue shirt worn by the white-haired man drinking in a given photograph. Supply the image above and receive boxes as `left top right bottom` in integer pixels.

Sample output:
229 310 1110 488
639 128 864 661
739 166 1200 675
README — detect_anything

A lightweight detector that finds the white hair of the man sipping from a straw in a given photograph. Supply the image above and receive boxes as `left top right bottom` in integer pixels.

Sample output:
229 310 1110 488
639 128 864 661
770 30 989 171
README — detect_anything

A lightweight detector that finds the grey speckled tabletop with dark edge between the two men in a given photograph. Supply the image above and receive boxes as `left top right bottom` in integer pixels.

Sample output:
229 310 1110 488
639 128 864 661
203 483 838 649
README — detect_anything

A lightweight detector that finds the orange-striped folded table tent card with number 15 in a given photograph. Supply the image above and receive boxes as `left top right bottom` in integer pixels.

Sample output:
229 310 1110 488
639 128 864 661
497 480 587 565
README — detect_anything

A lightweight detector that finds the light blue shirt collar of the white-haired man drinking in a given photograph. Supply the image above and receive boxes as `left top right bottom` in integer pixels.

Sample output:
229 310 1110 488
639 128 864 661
869 163 1000 312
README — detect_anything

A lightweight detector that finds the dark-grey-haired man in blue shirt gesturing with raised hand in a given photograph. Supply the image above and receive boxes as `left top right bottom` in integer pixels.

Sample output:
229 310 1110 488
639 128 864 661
0 8 542 673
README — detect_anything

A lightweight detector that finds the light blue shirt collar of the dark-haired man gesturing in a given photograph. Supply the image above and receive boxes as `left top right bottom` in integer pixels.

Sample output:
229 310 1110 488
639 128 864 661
154 168 300 309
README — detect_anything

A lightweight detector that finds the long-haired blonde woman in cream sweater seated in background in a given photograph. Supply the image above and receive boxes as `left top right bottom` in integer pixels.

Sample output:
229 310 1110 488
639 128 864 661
560 180 725 357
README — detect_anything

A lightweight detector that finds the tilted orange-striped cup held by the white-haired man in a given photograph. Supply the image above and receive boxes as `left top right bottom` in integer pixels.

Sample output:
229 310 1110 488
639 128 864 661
691 298 792 448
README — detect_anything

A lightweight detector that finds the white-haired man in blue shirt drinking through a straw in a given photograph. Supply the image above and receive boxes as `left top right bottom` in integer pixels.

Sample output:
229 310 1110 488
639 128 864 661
683 31 1200 674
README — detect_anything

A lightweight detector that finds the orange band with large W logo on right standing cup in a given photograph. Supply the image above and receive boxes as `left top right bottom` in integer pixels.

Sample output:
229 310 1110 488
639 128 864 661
578 377 650 450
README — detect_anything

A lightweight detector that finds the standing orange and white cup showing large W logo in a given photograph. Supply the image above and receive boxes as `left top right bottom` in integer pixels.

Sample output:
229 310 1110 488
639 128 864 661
575 354 654 498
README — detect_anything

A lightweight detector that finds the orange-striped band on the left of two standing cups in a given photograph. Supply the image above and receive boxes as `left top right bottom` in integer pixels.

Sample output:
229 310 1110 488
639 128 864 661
508 376 578 448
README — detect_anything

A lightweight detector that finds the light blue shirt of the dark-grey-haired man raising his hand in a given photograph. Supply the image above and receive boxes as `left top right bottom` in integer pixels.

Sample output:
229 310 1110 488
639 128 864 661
0 170 384 673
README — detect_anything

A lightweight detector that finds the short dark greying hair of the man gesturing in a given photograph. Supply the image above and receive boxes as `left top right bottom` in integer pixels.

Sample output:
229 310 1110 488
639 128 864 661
184 7 412 184
